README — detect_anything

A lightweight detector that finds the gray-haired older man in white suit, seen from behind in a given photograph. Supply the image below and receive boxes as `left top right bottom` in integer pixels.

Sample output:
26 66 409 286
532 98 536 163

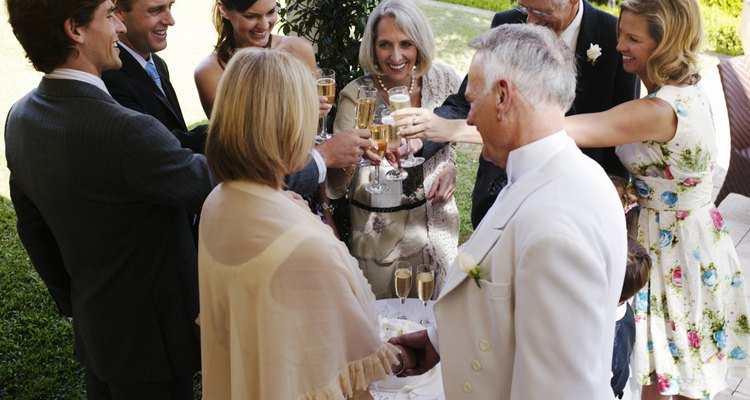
392 25 626 400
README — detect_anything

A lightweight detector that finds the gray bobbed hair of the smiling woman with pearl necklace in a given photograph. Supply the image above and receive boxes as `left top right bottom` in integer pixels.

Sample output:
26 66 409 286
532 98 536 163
359 0 435 76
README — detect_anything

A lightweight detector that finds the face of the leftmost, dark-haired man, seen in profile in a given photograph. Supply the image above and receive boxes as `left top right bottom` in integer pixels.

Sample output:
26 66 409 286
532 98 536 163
76 0 126 76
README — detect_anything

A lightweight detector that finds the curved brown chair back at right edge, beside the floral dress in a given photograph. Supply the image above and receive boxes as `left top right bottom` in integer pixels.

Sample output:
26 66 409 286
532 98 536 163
715 56 750 205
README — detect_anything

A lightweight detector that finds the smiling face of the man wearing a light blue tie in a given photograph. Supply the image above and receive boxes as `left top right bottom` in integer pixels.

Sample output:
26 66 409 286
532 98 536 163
116 0 174 60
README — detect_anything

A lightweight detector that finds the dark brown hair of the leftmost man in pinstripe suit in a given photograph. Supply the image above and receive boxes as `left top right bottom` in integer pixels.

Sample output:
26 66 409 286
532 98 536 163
7 0 104 73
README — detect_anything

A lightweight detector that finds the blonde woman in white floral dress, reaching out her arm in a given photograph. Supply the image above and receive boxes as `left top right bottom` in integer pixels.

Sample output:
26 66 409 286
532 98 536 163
566 0 750 399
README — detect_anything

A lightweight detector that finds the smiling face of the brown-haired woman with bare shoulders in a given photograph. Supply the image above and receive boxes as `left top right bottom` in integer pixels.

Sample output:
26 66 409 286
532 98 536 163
223 0 278 48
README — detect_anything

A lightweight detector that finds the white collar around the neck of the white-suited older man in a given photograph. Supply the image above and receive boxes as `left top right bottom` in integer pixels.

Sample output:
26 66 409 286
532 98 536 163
505 130 571 185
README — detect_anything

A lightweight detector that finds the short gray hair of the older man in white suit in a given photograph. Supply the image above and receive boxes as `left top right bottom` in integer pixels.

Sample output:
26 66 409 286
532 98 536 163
469 24 576 110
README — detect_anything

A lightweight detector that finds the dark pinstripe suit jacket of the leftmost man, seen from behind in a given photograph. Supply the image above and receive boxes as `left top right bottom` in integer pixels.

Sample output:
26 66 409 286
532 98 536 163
5 78 214 382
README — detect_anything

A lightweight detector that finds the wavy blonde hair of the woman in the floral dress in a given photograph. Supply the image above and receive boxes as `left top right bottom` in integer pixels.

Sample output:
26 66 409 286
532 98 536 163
618 0 703 87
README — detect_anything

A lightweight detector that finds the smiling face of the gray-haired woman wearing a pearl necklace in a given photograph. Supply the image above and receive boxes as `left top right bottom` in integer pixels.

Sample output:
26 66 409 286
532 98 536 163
375 16 417 83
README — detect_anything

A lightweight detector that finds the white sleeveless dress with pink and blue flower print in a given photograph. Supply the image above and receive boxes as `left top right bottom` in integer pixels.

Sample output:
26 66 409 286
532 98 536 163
617 85 750 399
